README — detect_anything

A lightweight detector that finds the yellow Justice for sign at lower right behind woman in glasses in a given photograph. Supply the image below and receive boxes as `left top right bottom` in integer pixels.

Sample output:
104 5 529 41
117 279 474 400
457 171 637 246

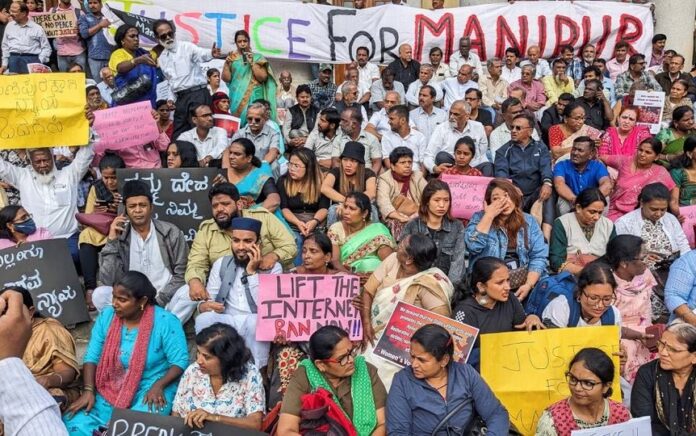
481 326 621 435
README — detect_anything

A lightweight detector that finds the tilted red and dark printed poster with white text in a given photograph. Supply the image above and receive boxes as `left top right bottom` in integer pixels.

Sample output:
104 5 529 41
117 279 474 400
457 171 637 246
372 302 478 367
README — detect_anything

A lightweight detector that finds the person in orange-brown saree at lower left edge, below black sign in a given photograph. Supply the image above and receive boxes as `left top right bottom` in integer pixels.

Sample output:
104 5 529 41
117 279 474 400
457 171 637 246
0 286 80 408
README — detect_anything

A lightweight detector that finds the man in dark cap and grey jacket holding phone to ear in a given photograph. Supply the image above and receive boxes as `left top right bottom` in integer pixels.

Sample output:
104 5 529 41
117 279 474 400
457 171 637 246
92 180 188 311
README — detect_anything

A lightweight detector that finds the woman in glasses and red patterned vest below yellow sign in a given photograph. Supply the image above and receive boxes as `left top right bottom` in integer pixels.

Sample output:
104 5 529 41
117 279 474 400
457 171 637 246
536 348 631 436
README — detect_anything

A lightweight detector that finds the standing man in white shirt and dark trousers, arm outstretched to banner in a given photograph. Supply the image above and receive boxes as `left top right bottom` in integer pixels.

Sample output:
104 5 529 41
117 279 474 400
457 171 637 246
152 20 225 139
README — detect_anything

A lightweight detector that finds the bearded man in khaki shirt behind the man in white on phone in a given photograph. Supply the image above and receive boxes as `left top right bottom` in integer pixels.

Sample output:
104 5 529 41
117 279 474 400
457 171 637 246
168 182 297 323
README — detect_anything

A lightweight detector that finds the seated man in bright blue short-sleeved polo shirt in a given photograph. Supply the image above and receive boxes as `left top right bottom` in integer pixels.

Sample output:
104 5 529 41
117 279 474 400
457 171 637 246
553 136 611 215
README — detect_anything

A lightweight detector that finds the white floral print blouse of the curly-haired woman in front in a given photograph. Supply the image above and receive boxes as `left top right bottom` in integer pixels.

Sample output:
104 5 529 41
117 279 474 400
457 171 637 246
172 363 266 418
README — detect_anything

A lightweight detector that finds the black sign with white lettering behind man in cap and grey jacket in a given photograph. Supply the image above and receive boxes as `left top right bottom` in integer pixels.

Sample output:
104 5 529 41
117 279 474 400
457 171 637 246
116 168 219 242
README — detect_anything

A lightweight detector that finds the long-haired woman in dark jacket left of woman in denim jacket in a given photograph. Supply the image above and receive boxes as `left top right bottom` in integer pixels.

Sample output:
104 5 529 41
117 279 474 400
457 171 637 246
401 179 466 283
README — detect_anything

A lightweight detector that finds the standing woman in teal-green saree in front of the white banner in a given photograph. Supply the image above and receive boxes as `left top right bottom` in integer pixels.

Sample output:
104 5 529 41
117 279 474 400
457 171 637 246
222 30 277 127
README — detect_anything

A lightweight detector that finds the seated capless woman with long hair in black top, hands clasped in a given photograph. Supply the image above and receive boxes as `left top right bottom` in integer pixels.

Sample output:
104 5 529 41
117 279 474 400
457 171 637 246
278 147 329 265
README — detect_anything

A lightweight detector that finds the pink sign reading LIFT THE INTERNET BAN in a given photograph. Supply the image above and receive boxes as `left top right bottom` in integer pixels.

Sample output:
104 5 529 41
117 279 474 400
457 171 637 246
256 274 362 341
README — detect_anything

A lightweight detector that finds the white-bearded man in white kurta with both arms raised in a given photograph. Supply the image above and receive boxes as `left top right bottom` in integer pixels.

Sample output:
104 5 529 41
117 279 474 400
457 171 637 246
0 111 98 265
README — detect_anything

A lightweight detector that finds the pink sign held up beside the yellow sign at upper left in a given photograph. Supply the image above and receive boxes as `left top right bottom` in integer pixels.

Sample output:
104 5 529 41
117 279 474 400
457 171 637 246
93 101 159 152
